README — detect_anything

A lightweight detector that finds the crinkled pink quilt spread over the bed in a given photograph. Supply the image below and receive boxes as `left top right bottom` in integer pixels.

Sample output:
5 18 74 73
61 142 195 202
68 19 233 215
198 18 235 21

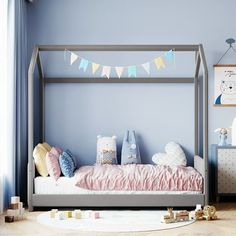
75 164 203 191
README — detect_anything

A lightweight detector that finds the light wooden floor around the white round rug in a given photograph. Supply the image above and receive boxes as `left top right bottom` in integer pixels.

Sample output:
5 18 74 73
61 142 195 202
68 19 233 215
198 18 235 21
0 203 236 236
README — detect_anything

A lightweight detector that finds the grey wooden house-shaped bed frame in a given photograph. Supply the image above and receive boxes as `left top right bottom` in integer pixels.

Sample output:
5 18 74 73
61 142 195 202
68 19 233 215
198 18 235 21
28 44 208 211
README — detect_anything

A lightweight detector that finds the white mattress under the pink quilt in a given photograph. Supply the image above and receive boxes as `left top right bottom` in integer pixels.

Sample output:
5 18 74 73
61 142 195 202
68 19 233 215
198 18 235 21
34 176 202 194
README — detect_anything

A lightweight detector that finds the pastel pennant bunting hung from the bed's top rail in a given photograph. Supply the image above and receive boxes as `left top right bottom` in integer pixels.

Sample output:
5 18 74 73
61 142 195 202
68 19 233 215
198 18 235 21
64 49 175 79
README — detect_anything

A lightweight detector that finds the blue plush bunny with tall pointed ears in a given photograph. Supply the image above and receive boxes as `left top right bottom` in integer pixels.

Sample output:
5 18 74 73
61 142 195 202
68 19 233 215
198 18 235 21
121 130 141 165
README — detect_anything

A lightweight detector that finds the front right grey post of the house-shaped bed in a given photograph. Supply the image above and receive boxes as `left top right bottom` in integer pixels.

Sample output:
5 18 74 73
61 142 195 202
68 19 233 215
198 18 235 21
199 44 209 204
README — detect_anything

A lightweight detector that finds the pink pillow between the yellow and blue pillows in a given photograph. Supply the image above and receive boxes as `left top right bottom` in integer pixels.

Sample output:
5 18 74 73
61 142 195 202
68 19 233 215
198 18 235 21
46 147 62 181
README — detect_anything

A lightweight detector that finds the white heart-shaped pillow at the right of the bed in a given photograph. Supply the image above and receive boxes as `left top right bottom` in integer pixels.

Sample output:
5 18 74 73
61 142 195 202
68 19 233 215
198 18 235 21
152 141 187 166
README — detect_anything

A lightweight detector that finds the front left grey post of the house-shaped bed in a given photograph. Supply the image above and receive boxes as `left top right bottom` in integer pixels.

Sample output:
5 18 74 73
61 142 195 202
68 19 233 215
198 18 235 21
27 46 38 211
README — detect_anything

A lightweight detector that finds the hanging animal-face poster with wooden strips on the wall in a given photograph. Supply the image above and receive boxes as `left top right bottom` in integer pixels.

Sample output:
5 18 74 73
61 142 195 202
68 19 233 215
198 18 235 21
214 65 236 106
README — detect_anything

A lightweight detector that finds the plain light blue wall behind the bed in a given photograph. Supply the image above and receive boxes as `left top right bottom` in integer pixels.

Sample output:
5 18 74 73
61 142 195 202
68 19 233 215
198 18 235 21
28 0 236 164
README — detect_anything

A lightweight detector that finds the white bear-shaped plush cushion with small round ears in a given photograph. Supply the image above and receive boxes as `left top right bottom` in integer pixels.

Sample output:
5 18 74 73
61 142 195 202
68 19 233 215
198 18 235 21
96 135 117 165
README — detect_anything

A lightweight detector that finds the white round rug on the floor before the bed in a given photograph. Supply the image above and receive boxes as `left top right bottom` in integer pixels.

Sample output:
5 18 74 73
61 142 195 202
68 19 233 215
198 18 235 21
37 210 194 232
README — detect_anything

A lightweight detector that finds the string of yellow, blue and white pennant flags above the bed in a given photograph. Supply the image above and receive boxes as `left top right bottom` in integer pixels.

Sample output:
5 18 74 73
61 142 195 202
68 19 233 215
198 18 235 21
64 49 175 78
